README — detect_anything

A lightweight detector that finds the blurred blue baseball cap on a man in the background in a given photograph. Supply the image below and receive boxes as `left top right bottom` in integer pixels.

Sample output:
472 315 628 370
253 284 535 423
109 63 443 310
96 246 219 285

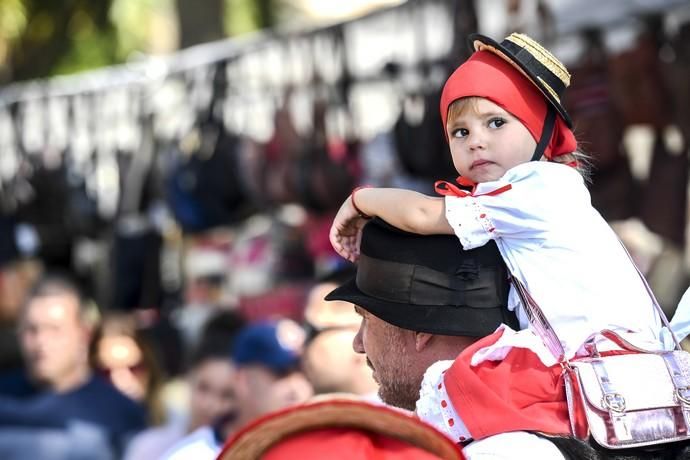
232 319 306 374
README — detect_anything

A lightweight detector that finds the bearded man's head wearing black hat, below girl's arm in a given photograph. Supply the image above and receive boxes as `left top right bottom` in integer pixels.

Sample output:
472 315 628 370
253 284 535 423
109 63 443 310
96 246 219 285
326 219 517 409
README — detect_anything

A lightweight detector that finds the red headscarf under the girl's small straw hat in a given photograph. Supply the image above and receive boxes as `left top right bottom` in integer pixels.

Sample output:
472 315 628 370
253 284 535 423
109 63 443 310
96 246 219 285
441 51 577 159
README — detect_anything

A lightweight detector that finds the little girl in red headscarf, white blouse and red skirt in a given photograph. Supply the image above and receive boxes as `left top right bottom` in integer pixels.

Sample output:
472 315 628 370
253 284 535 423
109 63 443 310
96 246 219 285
331 34 662 439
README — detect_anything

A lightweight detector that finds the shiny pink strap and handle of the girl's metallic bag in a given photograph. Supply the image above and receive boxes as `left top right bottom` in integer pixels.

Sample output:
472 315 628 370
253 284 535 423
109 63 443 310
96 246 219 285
510 240 682 363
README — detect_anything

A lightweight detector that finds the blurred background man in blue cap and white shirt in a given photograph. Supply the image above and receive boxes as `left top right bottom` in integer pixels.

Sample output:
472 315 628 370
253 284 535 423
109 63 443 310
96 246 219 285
163 320 313 460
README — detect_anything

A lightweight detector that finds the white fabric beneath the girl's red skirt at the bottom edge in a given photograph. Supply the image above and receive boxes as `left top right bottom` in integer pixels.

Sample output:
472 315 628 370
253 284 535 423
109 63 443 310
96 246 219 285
463 431 565 460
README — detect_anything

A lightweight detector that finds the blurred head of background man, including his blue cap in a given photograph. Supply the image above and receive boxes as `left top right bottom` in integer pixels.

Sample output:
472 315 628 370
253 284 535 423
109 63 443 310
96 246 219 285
232 320 313 422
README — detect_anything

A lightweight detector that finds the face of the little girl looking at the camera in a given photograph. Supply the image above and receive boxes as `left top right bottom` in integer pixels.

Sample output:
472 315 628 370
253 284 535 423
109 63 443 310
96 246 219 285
446 97 537 183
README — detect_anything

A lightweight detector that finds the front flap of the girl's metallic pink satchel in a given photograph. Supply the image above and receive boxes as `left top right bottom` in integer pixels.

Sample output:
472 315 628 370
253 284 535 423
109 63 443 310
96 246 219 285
570 351 690 412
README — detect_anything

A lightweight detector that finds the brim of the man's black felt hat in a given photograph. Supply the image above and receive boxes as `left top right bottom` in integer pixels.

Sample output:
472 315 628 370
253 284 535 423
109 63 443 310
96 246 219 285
325 278 517 337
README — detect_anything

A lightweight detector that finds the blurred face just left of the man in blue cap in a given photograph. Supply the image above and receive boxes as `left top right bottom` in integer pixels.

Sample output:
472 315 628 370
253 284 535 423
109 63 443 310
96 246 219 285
189 358 236 431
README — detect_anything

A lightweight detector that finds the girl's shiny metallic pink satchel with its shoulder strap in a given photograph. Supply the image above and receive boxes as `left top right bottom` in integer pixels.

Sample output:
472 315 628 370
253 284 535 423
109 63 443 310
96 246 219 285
513 252 690 449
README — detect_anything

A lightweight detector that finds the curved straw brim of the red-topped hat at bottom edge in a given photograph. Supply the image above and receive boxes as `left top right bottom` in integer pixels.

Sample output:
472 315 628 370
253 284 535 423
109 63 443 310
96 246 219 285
218 396 463 460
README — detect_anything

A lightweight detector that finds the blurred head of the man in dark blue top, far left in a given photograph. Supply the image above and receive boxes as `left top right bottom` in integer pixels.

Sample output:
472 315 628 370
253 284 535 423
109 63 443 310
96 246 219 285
19 277 91 391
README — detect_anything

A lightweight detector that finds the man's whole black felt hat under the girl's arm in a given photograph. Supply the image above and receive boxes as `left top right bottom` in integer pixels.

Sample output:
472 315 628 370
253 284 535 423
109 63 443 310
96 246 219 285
326 219 517 337
